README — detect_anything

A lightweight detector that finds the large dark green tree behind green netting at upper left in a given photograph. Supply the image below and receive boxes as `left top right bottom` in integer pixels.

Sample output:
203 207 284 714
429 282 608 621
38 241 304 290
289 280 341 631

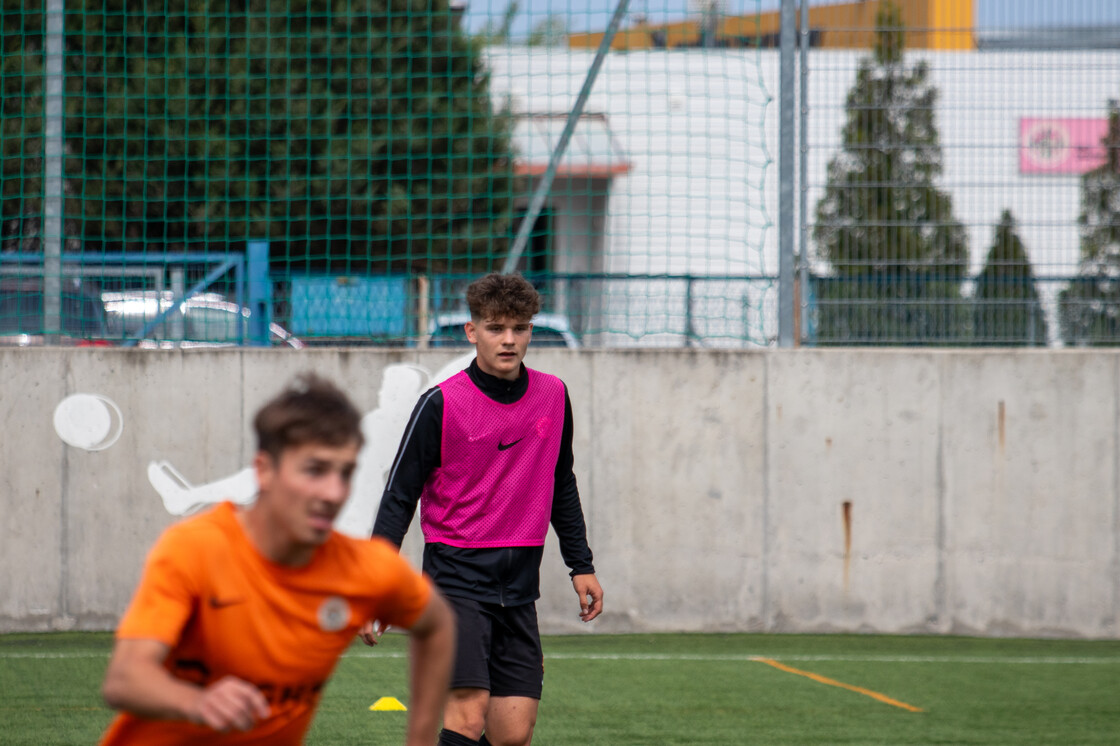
2 0 513 272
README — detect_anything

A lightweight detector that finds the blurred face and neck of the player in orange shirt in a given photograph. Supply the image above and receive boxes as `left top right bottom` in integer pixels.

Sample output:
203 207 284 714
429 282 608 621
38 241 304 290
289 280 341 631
251 442 358 565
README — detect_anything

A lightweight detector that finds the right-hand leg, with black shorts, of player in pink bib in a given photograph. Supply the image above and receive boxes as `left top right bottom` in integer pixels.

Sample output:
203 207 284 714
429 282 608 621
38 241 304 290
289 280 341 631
482 604 544 746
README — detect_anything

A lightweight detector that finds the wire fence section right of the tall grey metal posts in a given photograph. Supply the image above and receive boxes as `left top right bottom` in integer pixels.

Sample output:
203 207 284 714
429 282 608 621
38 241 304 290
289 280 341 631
802 0 1120 345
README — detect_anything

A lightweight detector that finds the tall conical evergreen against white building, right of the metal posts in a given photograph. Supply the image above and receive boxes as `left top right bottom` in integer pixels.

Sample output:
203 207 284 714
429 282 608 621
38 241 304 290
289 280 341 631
813 2 969 344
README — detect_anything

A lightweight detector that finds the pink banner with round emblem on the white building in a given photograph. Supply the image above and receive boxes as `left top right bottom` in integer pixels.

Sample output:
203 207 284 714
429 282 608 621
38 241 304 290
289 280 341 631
1019 118 1109 174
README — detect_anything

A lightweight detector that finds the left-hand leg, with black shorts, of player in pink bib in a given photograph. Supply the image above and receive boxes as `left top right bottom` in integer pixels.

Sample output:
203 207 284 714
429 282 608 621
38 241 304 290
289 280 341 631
439 596 493 746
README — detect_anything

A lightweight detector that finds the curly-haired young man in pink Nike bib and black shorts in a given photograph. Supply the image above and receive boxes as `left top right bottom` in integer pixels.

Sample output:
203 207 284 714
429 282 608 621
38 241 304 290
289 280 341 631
363 273 603 746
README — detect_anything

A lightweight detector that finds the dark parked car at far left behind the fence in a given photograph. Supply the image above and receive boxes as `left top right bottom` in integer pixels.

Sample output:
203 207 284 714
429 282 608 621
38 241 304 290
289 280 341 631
0 277 110 347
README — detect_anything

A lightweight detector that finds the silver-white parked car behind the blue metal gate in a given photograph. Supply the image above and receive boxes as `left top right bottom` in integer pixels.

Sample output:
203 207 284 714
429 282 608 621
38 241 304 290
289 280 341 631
101 290 304 349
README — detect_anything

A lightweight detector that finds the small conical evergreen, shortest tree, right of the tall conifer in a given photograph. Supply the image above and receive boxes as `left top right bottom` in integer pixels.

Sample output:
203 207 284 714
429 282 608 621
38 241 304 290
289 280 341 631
972 209 1047 346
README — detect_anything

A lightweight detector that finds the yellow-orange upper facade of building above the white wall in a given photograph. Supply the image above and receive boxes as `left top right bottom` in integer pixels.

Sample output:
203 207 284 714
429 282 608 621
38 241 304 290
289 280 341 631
568 0 976 50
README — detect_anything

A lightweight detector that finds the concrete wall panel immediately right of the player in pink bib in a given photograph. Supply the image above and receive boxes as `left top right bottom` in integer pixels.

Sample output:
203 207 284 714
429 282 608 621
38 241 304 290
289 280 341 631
577 351 765 630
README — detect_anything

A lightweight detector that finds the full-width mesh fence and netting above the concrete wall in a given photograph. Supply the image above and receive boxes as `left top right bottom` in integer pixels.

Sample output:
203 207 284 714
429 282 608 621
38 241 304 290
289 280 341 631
0 0 1120 346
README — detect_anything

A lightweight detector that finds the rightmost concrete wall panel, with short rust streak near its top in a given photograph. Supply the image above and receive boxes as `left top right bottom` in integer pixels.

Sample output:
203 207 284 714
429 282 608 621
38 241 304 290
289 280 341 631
942 351 1120 636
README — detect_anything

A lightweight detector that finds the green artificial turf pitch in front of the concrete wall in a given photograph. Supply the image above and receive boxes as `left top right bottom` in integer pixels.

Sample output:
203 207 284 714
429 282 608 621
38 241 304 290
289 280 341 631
0 633 1120 746
